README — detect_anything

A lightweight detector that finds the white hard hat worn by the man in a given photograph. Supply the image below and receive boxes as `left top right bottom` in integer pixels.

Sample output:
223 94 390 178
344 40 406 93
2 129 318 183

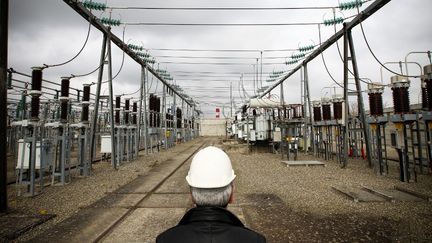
186 146 236 188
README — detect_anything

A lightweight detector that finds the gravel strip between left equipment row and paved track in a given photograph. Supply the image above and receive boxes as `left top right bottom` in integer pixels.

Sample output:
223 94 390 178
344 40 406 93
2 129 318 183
8 138 202 241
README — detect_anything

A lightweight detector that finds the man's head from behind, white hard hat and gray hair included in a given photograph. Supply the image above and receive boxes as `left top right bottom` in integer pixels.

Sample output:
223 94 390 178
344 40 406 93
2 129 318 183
186 146 236 207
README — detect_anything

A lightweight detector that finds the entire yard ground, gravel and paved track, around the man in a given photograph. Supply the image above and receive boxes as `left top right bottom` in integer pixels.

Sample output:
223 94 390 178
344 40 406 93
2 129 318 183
2 137 432 242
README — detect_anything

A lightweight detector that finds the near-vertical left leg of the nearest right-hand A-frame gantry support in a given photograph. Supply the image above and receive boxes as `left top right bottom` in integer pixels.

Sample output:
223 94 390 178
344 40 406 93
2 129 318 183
340 23 349 168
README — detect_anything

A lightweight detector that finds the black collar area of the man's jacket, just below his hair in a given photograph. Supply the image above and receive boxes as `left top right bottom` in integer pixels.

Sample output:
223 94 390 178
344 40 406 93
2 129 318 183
179 207 244 227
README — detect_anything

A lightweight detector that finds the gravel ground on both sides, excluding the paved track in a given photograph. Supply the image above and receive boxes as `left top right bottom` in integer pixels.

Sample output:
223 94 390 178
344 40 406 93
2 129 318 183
4 138 432 242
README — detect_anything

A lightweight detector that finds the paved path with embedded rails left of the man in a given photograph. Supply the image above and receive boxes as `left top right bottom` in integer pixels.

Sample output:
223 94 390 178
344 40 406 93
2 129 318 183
31 139 211 242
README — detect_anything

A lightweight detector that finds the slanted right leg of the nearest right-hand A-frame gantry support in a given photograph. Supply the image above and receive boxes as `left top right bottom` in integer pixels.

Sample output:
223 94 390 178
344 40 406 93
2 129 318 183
345 30 372 167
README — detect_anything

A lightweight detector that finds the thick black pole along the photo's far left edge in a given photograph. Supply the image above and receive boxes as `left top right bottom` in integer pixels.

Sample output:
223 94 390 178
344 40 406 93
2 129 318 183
0 0 9 213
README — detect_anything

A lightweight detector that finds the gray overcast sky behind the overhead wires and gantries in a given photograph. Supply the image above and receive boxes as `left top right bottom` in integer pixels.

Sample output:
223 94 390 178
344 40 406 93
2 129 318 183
9 0 432 117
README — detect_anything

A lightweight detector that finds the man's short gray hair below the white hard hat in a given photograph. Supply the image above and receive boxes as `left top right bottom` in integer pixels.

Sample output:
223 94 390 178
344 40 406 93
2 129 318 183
191 183 233 207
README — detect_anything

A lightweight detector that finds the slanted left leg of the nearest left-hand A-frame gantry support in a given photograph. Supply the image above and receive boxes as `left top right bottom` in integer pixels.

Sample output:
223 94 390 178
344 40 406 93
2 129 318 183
89 35 107 165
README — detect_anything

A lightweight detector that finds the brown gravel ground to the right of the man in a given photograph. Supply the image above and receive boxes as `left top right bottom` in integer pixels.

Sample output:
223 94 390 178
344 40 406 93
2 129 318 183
225 145 432 242
